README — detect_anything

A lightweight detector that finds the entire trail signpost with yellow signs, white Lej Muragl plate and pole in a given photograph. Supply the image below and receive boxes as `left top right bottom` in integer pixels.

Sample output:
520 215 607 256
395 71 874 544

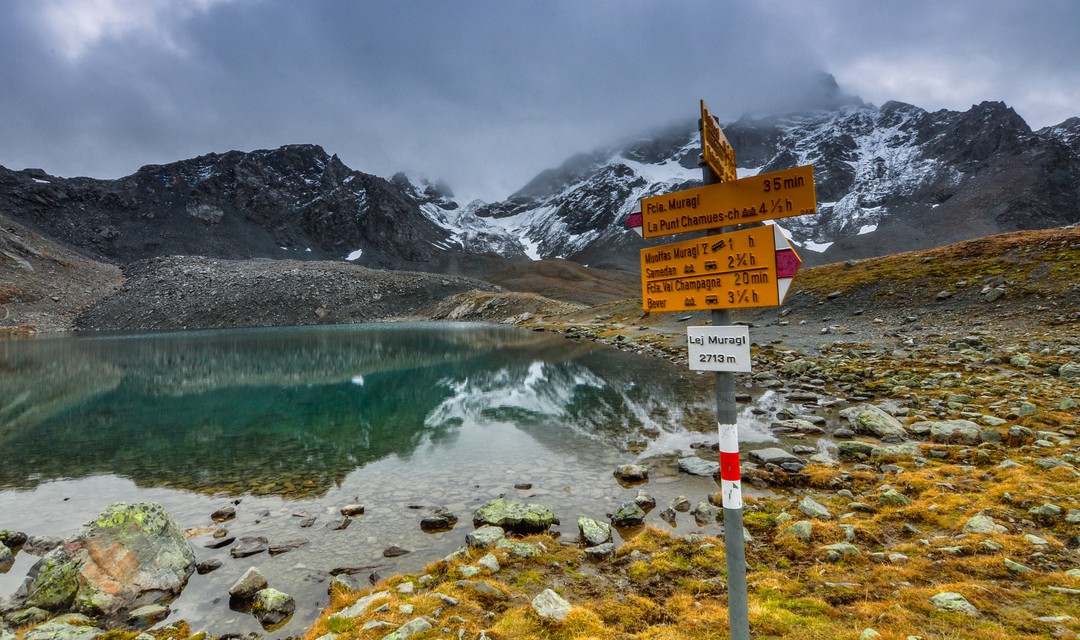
627 100 818 640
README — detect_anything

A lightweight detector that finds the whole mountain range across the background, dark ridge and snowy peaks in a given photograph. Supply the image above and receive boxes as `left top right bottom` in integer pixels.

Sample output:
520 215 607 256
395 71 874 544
0 100 1080 276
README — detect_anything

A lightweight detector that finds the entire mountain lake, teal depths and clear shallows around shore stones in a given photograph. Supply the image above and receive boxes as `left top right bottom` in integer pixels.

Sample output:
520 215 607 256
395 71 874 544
0 324 774 636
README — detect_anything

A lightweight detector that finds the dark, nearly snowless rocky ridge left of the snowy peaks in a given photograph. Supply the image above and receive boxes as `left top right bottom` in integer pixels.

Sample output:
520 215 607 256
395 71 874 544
0 145 481 271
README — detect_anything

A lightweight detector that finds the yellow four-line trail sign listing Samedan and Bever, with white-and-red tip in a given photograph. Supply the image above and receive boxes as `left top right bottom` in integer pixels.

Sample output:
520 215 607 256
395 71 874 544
642 226 799 311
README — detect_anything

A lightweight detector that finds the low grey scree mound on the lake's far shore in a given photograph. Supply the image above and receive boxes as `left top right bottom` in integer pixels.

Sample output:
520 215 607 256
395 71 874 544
76 256 498 330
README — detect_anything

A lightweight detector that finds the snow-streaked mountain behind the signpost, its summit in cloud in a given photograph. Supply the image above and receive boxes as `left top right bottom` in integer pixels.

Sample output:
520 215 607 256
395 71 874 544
410 100 1080 270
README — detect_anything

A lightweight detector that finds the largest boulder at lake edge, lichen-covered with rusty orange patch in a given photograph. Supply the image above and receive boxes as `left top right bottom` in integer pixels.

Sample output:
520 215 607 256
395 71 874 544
14 503 195 616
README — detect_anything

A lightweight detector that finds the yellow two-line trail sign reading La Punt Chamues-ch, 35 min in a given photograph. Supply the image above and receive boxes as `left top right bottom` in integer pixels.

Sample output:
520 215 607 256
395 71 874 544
642 164 818 237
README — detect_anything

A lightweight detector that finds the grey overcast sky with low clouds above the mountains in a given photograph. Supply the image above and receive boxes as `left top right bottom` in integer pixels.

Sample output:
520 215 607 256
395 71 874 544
0 0 1080 201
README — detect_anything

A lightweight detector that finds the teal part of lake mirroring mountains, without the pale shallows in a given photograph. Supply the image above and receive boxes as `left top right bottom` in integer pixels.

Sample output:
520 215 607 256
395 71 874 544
0 324 702 498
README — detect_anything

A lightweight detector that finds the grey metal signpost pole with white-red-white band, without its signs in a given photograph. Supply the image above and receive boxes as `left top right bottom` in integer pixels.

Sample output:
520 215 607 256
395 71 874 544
702 152 750 640
